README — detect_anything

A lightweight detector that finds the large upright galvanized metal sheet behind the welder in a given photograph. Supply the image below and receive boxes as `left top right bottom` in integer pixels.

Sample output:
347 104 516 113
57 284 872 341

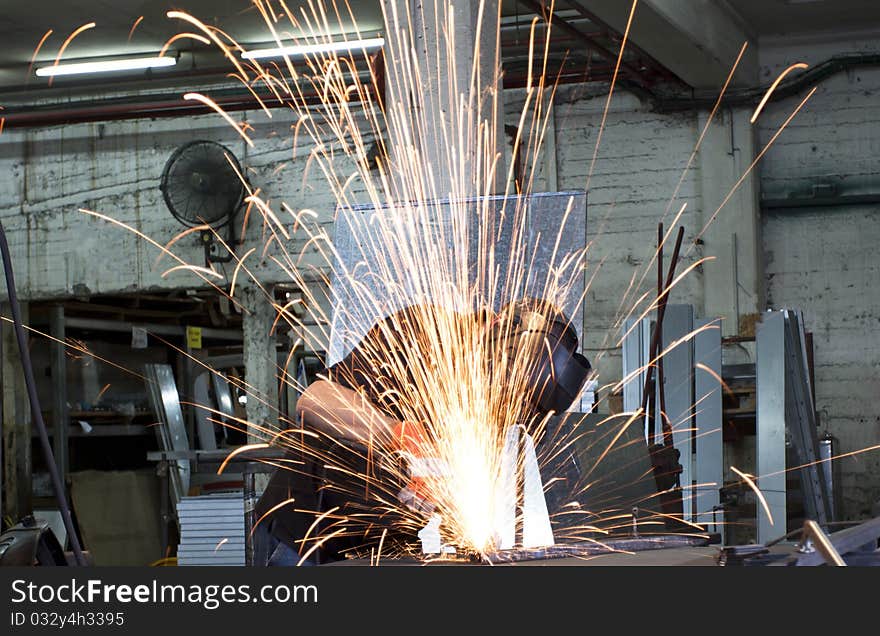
326 191 587 366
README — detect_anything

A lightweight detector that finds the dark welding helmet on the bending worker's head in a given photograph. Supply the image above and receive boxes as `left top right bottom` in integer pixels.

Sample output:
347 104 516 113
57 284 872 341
499 298 592 416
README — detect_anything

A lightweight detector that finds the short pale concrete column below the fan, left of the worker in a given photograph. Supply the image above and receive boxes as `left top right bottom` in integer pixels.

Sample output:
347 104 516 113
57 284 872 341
240 285 278 443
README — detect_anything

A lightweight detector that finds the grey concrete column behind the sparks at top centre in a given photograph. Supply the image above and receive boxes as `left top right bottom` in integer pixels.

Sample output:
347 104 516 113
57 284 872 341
385 0 506 198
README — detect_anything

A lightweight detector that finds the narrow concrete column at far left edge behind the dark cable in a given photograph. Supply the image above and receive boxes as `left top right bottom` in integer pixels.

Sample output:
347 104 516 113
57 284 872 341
0 303 33 523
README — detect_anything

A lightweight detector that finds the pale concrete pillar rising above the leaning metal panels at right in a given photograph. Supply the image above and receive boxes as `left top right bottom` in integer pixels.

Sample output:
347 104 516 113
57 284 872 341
698 109 764 336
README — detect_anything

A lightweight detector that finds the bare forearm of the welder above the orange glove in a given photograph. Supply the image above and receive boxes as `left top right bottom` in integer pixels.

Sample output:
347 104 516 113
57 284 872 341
296 380 398 444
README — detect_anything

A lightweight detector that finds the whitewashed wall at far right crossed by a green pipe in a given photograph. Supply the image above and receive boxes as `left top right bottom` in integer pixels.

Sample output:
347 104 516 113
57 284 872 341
760 33 880 518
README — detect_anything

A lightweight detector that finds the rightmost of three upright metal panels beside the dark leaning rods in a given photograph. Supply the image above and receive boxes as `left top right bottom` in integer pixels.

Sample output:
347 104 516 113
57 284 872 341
694 318 724 536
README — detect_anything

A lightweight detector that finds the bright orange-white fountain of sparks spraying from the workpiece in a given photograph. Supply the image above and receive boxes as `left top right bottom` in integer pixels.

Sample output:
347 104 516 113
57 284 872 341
77 1 832 564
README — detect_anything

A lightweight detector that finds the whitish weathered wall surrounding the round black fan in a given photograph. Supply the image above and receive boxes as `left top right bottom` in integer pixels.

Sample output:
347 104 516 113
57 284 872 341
0 99 358 298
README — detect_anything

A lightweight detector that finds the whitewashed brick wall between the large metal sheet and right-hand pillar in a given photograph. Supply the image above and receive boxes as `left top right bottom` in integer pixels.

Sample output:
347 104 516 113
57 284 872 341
555 87 703 385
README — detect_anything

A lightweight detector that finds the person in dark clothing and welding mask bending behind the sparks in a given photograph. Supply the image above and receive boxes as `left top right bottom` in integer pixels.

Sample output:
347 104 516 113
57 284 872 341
254 299 590 566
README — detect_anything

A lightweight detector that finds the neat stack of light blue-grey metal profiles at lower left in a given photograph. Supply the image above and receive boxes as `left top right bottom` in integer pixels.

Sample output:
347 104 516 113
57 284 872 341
177 492 245 565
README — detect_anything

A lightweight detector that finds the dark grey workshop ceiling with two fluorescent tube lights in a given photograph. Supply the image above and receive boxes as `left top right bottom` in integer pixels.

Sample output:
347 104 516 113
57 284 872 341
0 0 880 105
